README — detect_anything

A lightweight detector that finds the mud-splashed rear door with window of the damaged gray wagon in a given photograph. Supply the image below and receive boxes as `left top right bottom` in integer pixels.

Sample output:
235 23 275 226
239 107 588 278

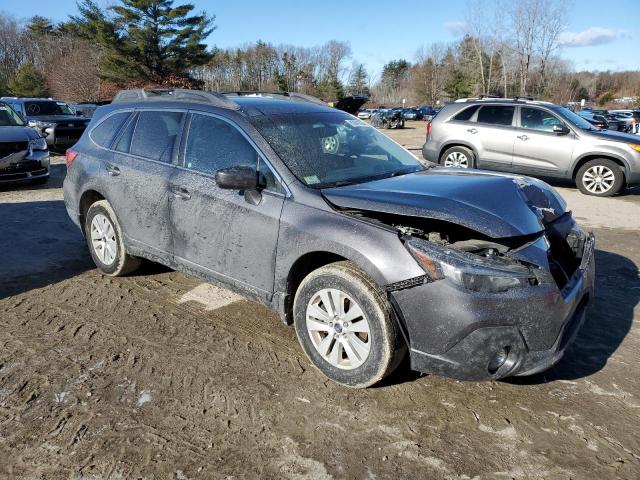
104 109 186 256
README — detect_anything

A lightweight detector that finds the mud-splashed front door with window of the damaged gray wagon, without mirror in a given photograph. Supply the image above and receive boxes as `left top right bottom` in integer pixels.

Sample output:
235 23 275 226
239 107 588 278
169 112 285 299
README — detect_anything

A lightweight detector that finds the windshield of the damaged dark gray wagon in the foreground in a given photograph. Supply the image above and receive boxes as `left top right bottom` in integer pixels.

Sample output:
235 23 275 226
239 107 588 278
252 112 425 188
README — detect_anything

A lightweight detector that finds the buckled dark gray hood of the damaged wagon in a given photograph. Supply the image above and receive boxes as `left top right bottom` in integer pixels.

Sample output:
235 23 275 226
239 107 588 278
322 168 566 238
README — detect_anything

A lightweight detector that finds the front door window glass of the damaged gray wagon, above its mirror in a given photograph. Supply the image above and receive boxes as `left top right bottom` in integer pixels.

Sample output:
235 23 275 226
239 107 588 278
184 114 258 175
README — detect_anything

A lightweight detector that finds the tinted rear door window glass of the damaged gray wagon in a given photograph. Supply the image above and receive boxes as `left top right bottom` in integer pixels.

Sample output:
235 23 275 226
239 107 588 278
129 110 183 163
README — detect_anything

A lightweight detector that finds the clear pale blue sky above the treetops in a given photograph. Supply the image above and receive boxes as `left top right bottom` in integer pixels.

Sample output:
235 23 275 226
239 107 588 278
0 0 640 77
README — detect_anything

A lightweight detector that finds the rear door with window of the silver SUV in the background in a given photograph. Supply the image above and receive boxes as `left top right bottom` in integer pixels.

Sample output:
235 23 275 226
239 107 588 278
467 105 516 171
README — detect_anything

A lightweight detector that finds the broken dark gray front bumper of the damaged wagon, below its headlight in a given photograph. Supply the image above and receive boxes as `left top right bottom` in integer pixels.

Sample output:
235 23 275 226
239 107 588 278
390 235 595 380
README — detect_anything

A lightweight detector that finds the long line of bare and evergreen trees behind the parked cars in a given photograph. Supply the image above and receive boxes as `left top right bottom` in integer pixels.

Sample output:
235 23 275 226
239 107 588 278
0 0 640 105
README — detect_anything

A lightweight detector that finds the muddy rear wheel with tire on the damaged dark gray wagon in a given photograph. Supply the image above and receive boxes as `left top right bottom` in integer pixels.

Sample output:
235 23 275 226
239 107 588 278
84 200 141 277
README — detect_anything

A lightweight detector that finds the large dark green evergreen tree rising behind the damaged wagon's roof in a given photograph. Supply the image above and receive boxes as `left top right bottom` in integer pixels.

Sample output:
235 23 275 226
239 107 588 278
70 0 215 83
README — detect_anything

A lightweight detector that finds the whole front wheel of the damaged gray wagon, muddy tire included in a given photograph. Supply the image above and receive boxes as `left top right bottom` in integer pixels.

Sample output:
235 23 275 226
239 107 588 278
293 262 405 388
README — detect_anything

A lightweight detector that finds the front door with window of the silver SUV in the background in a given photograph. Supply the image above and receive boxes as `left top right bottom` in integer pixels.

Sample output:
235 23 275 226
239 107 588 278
513 106 577 176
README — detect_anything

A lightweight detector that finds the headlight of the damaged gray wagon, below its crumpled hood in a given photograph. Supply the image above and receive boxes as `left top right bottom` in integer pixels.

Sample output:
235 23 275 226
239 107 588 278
405 239 538 293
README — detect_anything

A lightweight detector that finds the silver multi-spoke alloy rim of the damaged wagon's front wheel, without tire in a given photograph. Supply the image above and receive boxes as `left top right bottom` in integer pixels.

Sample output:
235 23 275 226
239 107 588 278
306 288 371 370
